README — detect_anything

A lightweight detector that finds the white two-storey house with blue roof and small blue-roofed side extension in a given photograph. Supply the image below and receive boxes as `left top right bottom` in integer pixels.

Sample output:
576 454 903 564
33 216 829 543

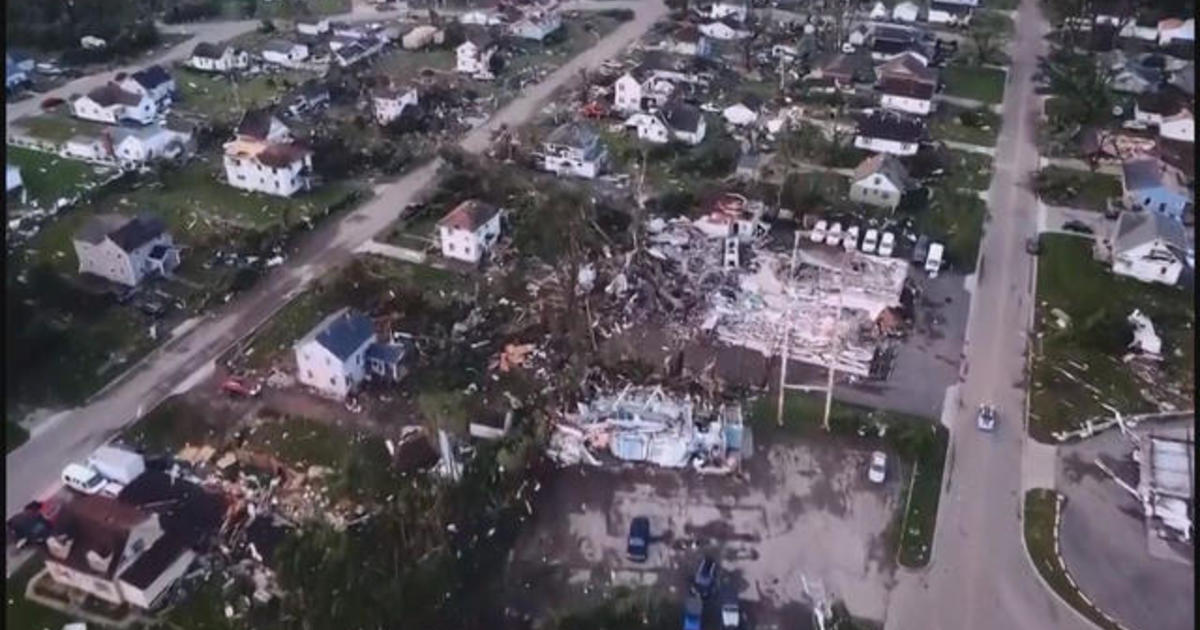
294 308 412 400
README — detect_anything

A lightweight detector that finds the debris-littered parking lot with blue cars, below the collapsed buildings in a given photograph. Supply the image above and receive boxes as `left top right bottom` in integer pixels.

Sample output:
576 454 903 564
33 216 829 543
508 438 907 628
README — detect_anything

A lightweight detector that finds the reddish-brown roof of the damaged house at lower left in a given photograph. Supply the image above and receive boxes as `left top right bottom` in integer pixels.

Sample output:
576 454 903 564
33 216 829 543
50 494 150 580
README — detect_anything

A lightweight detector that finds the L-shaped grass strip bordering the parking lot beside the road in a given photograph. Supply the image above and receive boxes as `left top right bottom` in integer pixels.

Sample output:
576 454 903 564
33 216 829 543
750 391 949 568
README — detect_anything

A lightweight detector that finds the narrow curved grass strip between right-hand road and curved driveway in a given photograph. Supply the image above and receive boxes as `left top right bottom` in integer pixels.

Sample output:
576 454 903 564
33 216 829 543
1025 488 1123 630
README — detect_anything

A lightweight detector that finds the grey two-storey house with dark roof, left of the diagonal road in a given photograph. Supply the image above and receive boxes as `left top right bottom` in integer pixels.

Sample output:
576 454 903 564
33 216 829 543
72 215 179 287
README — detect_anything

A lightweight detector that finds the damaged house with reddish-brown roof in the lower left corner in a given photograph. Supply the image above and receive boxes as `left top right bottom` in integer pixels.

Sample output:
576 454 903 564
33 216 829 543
46 496 196 610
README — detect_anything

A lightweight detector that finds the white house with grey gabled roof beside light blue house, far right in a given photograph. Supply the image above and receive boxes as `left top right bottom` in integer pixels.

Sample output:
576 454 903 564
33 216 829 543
1112 212 1188 286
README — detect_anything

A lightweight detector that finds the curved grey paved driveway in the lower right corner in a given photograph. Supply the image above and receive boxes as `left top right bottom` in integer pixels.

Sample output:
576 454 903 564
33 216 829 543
1057 422 1195 630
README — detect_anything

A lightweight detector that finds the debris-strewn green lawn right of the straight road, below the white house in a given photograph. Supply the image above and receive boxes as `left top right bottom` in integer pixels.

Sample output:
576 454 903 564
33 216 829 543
1030 234 1195 442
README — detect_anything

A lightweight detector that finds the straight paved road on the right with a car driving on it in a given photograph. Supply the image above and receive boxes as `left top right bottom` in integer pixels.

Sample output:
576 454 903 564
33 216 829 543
887 0 1091 630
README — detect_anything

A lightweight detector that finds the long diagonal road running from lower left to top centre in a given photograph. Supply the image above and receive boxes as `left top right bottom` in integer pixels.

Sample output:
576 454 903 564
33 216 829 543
5 1 666 515
